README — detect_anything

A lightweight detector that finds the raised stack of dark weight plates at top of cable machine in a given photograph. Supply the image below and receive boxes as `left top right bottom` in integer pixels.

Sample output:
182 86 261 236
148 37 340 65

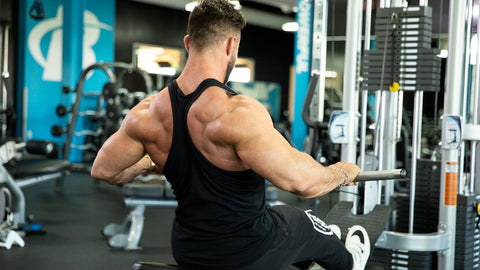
362 4 441 92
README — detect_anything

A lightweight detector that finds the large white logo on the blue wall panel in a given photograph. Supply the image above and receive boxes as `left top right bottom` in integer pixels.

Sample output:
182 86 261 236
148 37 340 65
28 6 112 82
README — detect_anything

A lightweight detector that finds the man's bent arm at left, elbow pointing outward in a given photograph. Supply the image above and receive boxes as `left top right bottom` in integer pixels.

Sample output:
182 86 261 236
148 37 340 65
91 110 153 184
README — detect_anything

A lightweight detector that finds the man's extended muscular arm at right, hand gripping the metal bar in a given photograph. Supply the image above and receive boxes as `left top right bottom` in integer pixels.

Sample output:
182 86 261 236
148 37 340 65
222 97 360 197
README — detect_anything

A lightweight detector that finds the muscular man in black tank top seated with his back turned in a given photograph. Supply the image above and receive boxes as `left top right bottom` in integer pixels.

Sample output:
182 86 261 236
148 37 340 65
91 0 369 270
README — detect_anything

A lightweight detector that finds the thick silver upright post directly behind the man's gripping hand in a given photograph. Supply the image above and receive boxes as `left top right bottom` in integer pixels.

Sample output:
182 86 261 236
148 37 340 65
340 0 363 204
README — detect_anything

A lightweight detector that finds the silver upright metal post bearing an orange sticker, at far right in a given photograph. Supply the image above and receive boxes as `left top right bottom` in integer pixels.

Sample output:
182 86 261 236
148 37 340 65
438 1 465 270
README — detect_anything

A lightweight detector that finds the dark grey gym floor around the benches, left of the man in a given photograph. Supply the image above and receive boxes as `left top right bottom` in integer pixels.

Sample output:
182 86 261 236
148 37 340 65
0 173 338 270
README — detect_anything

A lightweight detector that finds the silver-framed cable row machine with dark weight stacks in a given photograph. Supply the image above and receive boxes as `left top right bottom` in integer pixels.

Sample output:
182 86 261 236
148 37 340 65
326 1 480 269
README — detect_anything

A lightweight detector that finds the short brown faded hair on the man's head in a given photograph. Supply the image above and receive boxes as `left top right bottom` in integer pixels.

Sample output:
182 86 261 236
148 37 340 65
187 0 246 51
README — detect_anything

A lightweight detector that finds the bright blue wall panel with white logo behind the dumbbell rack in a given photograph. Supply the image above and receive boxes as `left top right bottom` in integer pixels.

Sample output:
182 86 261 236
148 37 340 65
17 0 115 162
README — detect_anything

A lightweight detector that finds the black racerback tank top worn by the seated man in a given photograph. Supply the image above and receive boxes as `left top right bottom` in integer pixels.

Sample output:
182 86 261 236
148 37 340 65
164 79 276 269
